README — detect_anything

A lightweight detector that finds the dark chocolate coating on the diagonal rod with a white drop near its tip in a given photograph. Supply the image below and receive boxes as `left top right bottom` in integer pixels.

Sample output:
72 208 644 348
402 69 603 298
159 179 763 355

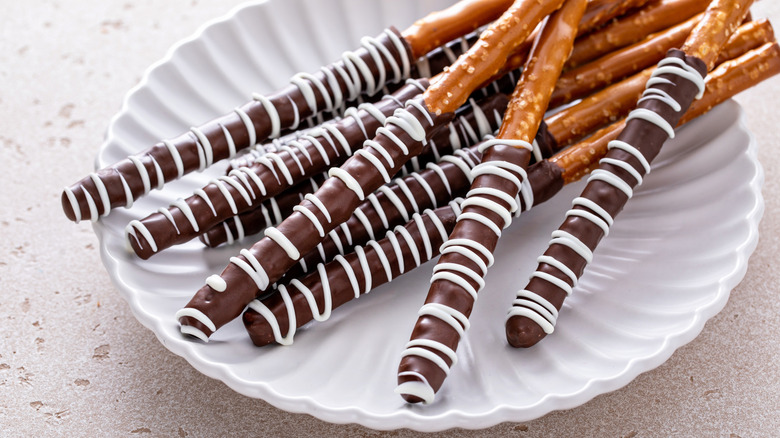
179 97 454 336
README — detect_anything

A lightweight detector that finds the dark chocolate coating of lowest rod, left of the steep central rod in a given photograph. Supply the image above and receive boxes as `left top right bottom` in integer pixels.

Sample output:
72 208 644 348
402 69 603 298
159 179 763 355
243 206 456 347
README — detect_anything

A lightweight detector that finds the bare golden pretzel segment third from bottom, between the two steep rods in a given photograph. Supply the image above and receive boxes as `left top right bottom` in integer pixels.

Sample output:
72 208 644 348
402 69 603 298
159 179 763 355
550 14 702 108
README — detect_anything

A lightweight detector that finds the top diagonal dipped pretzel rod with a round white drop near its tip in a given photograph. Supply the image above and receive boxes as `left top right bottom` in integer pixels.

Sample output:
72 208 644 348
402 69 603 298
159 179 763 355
176 0 560 337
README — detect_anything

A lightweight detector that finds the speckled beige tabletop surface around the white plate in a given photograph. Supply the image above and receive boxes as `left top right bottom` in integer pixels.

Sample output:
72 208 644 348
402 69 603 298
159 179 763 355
0 0 780 437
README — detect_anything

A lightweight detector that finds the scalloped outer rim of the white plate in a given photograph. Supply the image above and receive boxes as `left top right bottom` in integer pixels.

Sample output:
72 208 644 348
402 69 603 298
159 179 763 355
88 0 764 432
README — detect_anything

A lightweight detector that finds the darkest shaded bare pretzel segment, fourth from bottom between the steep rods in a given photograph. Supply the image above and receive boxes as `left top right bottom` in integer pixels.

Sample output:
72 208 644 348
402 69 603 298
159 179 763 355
564 0 710 70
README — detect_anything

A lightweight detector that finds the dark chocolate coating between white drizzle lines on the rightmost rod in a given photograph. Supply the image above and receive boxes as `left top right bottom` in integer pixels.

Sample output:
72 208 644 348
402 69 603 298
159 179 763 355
506 49 707 347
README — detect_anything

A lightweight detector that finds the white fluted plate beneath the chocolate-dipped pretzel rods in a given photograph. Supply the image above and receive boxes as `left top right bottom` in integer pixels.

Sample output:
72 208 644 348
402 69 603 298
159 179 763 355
95 0 763 431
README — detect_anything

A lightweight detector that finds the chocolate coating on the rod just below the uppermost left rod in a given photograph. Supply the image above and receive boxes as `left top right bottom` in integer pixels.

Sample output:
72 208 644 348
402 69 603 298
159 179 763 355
129 80 427 259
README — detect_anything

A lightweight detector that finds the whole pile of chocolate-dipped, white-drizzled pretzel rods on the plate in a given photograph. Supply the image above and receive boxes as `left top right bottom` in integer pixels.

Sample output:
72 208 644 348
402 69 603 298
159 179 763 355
62 0 780 403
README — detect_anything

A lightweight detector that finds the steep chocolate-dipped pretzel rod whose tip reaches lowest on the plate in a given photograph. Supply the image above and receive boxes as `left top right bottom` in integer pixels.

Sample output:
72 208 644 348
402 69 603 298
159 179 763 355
396 0 586 403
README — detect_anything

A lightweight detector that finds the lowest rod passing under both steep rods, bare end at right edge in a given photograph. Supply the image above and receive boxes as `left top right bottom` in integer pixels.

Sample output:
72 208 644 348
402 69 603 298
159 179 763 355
243 38 780 352
